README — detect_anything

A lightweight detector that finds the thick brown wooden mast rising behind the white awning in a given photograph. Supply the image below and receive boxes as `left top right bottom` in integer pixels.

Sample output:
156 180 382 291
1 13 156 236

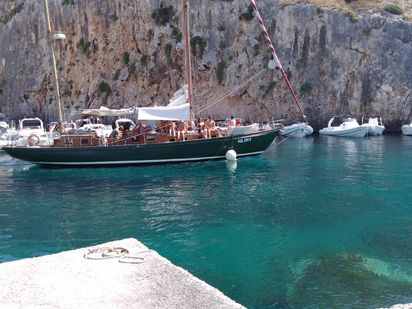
182 0 193 120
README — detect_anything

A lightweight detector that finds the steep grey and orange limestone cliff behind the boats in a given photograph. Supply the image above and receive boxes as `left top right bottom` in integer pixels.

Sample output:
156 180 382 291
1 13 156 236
0 0 412 130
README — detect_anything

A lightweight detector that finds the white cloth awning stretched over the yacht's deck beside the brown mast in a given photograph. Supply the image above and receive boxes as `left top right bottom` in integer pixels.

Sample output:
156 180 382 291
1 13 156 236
138 103 190 120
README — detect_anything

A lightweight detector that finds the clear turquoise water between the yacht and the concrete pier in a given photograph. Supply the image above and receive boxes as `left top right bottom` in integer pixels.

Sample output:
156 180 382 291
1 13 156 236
0 135 412 308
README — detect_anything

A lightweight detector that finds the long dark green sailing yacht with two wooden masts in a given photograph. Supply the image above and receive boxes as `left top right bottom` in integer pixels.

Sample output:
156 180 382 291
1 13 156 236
4 0 279 167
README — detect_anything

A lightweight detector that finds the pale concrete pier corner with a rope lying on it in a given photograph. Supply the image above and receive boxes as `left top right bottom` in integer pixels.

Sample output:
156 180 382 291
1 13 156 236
0 239 244 309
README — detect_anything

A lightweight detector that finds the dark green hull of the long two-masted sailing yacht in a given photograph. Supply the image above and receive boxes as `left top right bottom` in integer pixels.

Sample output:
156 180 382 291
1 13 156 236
3 130 279 166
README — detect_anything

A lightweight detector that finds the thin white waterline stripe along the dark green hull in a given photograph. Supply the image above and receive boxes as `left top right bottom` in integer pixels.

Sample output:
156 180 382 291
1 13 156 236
33 151 263 165
